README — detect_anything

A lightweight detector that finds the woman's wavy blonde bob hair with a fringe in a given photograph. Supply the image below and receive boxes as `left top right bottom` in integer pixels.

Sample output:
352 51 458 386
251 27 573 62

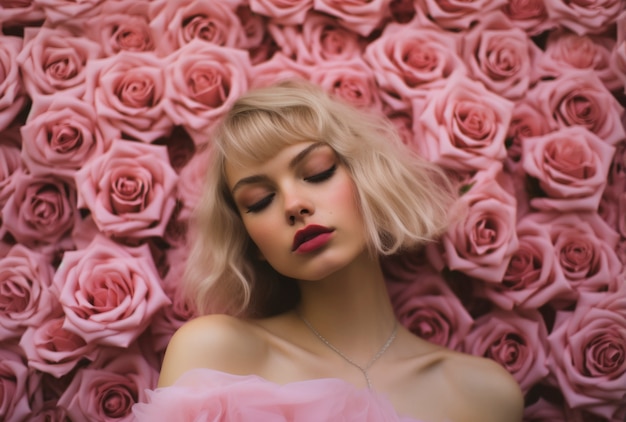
183 81 455 317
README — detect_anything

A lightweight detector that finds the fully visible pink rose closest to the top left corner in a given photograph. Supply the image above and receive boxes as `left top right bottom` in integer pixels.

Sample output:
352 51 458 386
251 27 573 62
17 27 101 99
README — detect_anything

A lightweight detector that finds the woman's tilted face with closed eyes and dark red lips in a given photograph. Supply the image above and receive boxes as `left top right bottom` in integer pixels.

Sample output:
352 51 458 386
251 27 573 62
226 142 367 280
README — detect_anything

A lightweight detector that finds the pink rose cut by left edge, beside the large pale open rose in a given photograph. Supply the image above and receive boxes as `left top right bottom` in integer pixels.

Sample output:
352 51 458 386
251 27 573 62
0 244 56 340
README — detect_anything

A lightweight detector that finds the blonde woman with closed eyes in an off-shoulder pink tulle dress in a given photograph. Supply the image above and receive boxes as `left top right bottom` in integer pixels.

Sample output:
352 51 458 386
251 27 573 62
135 82 523 422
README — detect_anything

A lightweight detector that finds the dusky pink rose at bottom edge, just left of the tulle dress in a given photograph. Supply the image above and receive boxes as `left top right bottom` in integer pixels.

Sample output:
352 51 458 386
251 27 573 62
59 348 158 422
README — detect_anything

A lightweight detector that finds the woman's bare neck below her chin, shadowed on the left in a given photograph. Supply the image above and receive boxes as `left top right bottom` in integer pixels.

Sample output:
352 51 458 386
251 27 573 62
296 254 395 365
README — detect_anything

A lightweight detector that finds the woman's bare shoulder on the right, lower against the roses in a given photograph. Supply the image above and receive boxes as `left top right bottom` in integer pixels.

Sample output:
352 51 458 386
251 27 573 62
444 352 524 422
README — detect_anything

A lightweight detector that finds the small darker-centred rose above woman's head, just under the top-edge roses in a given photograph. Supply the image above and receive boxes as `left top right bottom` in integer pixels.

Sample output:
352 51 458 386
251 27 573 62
291 13 362 64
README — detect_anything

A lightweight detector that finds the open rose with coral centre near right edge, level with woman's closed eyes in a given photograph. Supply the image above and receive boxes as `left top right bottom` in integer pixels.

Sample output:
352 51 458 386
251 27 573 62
522 126 615 212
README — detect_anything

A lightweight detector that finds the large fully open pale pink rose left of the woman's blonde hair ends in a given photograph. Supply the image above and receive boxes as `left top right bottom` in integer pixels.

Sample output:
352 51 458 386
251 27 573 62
53 236 170 347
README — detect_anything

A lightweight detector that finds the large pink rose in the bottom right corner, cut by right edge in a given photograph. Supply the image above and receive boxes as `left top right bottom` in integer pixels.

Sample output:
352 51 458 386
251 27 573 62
548 290 626 418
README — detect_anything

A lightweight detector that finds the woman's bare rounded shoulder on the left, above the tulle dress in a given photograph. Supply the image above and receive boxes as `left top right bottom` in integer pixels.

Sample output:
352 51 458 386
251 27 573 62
159 315 265 387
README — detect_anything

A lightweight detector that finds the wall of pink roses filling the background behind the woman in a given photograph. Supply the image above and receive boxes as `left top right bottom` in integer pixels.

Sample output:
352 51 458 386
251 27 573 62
0 0 626 421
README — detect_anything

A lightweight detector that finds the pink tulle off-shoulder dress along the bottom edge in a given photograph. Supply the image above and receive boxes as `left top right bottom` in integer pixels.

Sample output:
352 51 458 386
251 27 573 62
133 369 416 422
